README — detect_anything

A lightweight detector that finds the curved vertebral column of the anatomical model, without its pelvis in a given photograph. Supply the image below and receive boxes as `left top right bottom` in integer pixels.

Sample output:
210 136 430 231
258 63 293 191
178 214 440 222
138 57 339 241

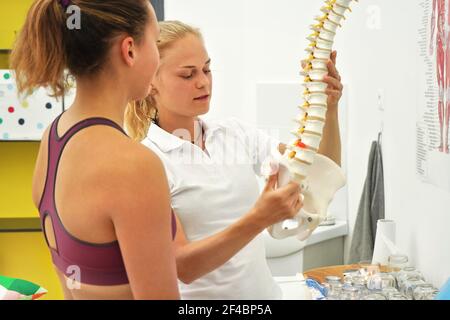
282 0 358 183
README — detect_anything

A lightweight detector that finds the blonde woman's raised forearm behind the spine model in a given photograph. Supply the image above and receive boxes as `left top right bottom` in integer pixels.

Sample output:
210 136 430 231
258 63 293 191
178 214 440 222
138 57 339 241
319 111 341 165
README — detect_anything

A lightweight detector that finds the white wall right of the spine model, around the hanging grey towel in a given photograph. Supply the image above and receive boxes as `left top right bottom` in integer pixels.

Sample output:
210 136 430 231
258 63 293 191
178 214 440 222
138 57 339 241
337 0 450 286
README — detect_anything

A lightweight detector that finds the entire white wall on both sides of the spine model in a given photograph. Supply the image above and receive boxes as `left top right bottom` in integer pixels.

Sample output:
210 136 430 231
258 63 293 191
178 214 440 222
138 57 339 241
166 0 450 286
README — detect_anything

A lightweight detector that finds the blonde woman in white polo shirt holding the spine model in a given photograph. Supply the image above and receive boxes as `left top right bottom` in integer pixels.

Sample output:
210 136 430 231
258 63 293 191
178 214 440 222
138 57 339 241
126 21 342 299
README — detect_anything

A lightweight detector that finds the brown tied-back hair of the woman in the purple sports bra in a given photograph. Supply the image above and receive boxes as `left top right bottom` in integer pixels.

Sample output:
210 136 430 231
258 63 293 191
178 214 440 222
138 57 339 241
11 0 150 97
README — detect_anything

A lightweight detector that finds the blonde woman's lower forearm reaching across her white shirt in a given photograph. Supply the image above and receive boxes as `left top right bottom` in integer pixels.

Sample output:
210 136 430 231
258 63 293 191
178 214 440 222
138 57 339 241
176 212 264 284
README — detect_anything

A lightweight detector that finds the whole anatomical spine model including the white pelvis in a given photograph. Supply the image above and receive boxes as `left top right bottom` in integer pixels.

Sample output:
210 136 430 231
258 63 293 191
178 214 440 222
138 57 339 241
268 0 358 240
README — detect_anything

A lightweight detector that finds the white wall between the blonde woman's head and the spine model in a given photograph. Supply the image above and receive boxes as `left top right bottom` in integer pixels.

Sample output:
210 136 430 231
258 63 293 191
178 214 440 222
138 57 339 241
166 0 320 123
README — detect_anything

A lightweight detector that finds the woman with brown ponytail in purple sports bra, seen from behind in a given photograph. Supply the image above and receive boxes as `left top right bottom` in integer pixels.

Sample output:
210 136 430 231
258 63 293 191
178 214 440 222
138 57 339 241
11 0 179 299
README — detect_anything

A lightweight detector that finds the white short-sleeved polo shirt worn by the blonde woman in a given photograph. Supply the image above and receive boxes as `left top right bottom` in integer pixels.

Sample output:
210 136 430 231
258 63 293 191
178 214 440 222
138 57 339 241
143 119 282 300
